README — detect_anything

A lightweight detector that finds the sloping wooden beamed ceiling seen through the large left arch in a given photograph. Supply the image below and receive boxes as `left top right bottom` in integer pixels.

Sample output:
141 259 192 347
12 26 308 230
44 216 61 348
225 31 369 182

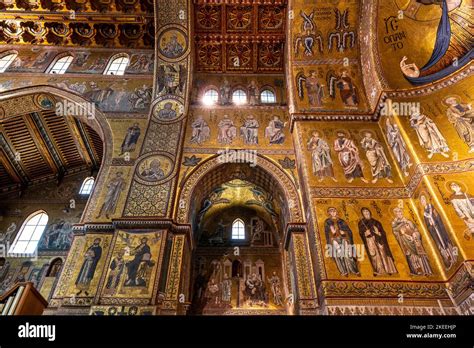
0 111 103 191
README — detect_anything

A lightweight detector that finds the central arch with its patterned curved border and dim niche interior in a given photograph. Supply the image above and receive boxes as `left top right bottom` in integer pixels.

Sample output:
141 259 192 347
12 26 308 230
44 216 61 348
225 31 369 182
175 155 304 315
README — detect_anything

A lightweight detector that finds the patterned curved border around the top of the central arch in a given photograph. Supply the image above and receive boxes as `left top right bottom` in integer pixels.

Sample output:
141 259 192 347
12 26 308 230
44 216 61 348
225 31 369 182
175 155 304 224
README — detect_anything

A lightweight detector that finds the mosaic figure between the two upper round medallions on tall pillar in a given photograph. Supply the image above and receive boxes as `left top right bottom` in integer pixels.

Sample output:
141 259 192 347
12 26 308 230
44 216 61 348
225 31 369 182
157 64 187 96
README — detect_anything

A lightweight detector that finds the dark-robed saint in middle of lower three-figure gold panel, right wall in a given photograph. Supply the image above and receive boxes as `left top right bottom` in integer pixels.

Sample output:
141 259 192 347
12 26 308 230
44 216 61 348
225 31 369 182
359 208 398 276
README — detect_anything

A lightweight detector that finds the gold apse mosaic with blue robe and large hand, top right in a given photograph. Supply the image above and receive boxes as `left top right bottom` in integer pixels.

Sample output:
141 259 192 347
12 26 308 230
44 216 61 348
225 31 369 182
378 0 473 88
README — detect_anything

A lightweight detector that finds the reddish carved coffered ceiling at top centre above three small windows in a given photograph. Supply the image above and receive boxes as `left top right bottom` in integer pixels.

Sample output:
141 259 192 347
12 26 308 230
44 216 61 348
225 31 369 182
194 0 286 73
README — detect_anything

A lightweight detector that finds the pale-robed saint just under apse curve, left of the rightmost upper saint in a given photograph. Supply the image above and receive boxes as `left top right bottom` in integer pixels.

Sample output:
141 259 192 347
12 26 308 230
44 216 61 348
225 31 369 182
410 108 450 158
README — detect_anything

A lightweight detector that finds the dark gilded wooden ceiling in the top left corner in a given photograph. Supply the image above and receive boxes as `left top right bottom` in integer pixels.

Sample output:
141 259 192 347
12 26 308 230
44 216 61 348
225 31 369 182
0 0 154 49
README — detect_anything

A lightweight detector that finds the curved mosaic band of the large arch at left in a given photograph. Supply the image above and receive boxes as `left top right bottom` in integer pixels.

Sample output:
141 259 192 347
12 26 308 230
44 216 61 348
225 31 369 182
0 85 113 223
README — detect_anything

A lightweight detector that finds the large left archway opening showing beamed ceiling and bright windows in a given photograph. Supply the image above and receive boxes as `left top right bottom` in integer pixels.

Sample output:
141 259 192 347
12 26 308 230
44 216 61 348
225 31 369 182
0 87 106 298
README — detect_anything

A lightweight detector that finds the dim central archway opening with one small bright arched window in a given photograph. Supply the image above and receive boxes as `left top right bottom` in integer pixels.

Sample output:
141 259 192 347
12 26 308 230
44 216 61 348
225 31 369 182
189 164 291 315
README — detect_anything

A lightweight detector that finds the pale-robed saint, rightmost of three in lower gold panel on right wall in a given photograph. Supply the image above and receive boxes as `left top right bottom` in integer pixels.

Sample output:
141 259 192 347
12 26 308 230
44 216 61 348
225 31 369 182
392 208 433 276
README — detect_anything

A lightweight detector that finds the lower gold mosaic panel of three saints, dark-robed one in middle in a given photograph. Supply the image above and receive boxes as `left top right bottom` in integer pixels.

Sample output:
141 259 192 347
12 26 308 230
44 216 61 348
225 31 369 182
315 199 441 279
